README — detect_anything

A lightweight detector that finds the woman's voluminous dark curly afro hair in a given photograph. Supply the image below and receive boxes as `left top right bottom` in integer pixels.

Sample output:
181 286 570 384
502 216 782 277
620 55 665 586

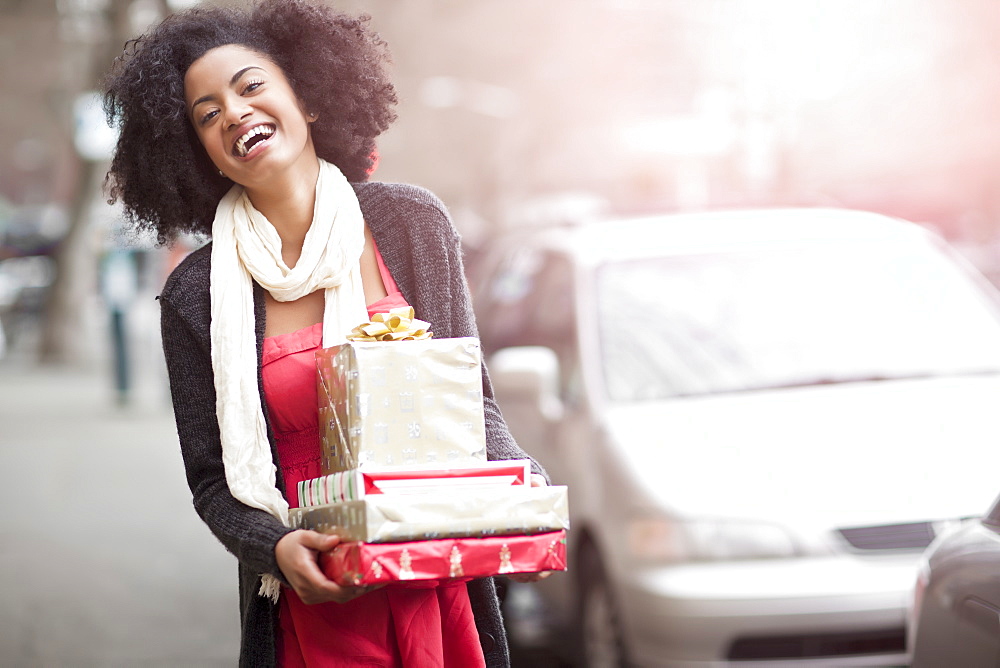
104 0 397 244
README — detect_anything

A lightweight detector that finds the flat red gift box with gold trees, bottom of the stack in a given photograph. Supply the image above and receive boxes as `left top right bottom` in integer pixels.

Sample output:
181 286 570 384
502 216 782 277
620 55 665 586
320 531 566 587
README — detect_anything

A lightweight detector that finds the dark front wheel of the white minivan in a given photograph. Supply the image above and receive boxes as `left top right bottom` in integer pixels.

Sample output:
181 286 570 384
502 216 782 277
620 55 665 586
577 547 629 668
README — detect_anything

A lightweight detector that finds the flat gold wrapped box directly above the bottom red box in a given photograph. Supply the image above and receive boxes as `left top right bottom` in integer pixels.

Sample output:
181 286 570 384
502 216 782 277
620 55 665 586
289 486 569 543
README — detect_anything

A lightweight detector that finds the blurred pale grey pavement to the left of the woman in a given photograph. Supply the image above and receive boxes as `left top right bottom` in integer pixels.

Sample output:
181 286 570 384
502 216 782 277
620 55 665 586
0 362 239 667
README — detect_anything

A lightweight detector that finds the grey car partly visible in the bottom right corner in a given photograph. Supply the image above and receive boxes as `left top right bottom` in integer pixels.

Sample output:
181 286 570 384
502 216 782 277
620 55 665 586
907 490 1000 668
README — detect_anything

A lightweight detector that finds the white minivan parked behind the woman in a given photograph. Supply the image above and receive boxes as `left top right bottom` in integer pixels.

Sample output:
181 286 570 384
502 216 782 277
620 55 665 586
470 209 1000 667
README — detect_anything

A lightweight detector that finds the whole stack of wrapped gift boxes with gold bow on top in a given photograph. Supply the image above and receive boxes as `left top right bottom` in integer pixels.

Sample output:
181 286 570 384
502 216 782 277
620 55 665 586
290 309 569 585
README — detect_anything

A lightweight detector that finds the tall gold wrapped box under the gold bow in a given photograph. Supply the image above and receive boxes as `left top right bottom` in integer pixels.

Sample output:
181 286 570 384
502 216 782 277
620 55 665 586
316 337 486 474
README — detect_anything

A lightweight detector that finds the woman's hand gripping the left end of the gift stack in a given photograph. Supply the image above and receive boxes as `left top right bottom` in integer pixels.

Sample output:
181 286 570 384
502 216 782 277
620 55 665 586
274 529 381 605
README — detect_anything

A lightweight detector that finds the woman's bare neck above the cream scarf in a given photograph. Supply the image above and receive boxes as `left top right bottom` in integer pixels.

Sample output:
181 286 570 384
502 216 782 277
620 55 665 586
246 162 319 267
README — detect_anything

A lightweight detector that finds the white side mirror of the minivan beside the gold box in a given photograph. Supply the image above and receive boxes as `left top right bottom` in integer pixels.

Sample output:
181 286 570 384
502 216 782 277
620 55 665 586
489 346 563 420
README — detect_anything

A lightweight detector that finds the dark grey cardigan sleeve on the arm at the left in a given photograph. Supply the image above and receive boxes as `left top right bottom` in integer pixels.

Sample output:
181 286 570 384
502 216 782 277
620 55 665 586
160 260 291 580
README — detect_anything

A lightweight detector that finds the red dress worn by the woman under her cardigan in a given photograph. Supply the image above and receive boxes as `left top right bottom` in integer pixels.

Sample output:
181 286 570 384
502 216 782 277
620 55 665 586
263 249 486 668
